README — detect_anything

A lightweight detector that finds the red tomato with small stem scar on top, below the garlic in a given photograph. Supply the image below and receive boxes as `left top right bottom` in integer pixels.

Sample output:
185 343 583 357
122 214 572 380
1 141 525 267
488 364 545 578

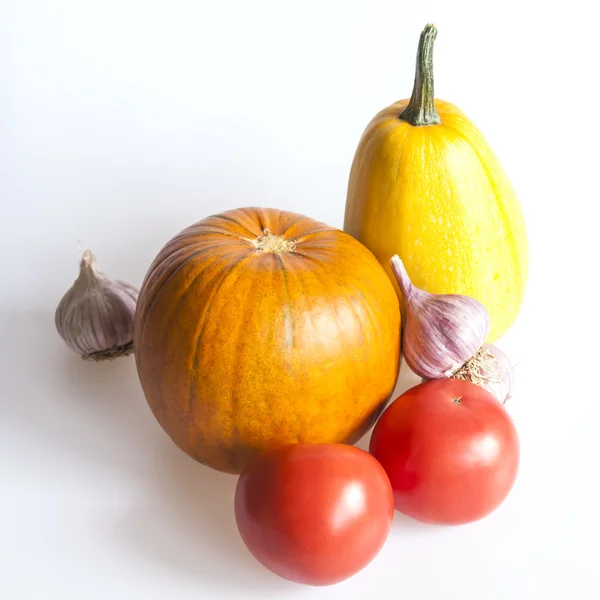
369 379 519 525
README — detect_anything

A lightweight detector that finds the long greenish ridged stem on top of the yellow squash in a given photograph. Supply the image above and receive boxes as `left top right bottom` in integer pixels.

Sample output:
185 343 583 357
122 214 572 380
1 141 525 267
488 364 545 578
398 24 442 127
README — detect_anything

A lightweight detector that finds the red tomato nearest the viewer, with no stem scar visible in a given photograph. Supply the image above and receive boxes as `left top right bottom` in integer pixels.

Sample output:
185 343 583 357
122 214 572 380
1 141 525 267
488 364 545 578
235 444 394 585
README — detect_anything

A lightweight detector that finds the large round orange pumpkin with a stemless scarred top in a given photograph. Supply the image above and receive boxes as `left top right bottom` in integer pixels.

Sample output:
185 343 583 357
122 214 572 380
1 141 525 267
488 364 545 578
134 208 400 473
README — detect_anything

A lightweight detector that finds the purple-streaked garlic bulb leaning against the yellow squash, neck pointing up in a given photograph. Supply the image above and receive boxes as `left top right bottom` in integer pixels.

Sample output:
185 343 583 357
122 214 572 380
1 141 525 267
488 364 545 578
391 255 490 379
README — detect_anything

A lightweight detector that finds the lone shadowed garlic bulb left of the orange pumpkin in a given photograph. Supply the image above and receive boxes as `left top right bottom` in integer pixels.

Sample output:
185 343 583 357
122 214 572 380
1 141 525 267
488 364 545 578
54 250 138 360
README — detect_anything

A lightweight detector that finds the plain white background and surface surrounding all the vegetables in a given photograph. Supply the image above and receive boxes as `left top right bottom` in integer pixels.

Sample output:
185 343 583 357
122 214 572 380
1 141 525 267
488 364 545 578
0 0 600 600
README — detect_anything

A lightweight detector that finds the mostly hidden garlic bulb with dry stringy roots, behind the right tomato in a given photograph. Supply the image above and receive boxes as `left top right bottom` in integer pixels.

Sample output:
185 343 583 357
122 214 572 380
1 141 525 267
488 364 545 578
452 344 513 404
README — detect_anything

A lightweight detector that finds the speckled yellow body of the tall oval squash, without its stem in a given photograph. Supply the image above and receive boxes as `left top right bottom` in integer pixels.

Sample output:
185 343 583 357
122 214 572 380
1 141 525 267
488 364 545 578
344 100 528 342
